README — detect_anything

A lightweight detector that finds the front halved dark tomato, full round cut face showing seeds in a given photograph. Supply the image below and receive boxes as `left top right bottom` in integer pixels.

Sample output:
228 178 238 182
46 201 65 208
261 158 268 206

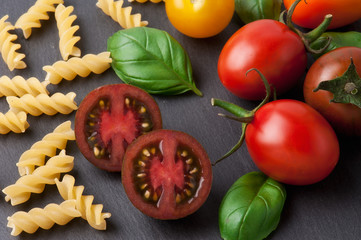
122 129 212 220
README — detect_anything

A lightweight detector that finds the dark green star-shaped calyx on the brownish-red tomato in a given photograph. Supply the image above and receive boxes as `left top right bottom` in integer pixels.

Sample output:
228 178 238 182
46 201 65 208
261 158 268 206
313 57 361 108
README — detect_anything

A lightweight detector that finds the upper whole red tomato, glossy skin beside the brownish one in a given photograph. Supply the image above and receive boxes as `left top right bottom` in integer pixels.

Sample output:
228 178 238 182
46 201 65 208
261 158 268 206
218 19 307 100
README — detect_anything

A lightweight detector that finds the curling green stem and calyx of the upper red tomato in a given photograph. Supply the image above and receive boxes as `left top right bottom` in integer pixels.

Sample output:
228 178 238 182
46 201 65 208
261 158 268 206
280 0 332 54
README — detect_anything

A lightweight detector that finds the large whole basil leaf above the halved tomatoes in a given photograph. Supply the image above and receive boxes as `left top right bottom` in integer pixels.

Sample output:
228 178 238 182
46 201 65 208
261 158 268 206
108 27 202 96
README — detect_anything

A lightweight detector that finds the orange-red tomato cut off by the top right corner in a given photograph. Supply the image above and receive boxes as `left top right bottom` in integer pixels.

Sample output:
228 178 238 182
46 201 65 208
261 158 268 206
283 0 361 29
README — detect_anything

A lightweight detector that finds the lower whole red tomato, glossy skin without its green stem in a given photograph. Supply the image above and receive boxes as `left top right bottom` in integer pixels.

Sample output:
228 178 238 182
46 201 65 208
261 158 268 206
245 99 339 185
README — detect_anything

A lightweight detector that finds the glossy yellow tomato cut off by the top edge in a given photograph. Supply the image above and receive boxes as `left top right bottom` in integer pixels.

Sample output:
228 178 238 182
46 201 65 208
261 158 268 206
165 0 234 38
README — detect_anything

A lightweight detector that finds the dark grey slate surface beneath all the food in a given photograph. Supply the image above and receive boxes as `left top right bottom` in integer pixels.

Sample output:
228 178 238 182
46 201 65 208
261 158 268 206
0 0 361 240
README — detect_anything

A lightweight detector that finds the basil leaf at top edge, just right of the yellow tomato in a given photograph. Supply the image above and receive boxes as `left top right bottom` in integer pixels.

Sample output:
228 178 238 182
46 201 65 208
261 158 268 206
235 0 282 23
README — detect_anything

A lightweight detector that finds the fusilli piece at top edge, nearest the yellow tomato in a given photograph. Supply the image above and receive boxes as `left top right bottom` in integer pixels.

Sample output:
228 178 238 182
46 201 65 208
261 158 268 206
96 0 148 28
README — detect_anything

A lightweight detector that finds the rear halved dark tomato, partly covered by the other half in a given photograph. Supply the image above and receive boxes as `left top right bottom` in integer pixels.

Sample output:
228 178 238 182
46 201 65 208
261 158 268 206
75 84 162 172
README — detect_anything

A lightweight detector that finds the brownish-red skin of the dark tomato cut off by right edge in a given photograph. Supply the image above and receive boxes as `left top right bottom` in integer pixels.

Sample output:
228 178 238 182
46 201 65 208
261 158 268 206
303 47 361 136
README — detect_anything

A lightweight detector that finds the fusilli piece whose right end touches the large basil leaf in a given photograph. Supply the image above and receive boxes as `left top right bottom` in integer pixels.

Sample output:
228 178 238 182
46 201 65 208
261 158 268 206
43 52 112 84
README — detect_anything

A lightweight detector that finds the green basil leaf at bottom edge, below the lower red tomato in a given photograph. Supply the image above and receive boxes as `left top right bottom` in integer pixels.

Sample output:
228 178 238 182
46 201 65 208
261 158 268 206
219 172 286 240
